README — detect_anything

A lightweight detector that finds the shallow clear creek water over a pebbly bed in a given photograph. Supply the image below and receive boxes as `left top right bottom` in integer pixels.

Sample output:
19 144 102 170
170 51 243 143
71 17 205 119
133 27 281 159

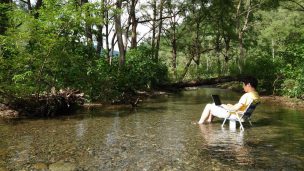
0 88 304 171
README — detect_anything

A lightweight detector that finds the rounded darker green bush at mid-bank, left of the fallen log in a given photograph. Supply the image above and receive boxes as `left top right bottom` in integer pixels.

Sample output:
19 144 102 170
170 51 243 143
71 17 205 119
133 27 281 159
88 46 168 102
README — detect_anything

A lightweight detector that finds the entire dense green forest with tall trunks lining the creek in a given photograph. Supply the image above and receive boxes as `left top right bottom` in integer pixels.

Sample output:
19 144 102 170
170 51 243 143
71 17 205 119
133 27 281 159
0 0 304 115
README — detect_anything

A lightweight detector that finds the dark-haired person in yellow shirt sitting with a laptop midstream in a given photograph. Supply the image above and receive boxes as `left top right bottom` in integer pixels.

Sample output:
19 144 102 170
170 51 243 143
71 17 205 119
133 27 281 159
198 76 260 124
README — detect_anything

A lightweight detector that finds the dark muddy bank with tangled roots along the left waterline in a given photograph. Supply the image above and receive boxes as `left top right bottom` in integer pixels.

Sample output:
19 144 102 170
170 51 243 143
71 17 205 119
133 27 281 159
0 87 85 118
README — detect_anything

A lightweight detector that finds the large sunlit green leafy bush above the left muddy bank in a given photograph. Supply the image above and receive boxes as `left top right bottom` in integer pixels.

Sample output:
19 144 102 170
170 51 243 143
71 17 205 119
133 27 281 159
0 1 94 100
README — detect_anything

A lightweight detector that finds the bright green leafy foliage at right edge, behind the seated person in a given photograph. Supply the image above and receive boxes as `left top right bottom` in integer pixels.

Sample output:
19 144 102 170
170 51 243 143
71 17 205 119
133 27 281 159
259 8 304 97
